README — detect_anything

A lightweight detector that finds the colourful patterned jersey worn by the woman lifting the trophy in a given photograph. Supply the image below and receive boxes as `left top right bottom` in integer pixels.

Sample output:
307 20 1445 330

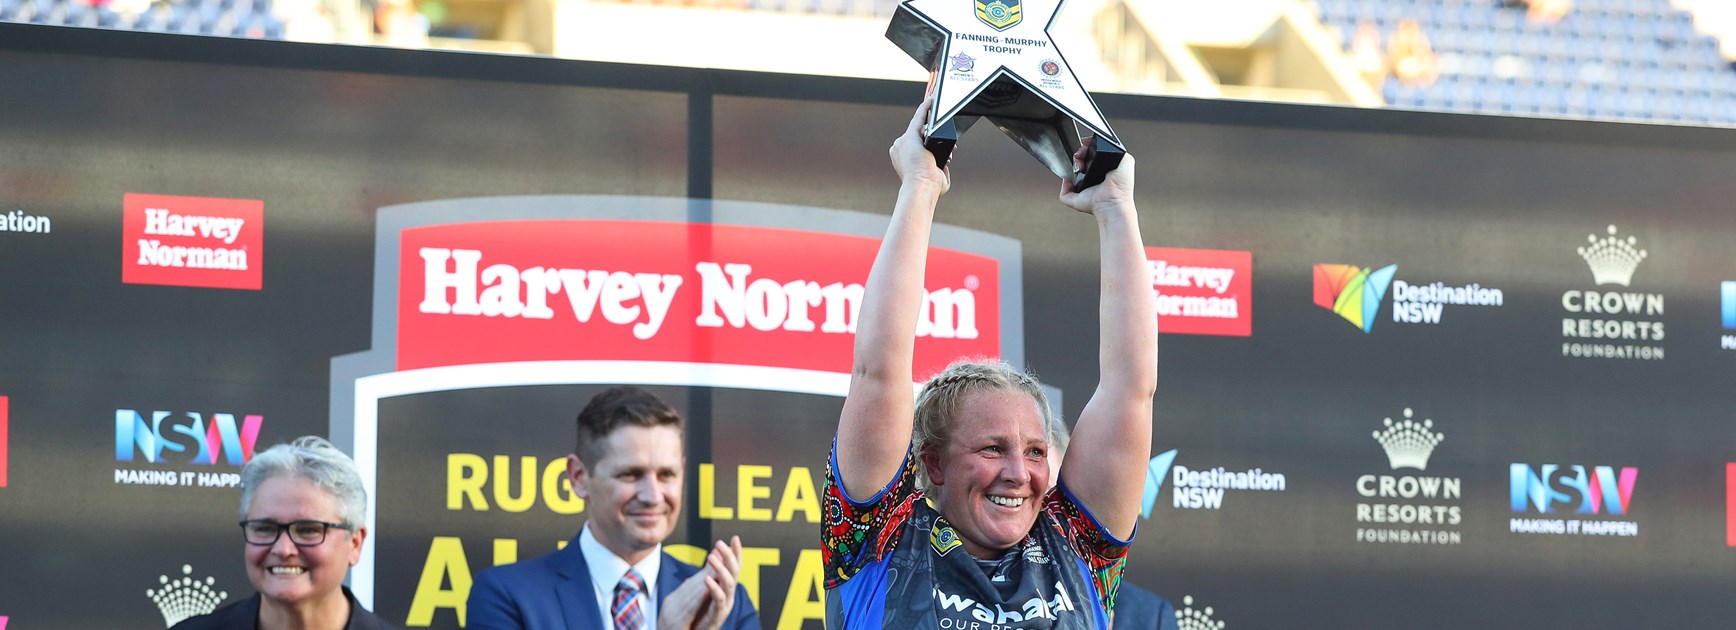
819 443 1128 630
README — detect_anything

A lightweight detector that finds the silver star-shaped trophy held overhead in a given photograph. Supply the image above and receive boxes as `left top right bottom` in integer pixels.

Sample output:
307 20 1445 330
885 0 1127 189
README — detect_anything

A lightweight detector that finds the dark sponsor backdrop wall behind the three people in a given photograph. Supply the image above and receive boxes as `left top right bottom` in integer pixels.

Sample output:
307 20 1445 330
0 24 1736 628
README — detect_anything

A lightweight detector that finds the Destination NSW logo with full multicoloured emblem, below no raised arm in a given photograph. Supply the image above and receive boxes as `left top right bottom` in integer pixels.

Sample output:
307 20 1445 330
1314 264 1505 333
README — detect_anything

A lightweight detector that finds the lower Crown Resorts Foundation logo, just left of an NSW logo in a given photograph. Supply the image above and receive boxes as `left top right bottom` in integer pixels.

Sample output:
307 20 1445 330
1356 408 1463 545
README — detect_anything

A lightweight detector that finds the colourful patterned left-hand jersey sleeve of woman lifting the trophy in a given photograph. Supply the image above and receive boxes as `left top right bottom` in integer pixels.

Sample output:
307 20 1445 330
819 441 920 588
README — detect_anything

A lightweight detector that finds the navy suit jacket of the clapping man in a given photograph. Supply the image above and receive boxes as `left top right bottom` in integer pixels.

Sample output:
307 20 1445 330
465 536 759 630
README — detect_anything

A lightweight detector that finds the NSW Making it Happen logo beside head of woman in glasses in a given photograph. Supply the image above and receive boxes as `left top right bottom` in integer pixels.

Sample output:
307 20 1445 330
115 410 266 488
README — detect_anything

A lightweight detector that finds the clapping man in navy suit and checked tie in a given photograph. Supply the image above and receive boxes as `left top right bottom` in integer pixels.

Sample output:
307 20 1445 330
467 387 759 630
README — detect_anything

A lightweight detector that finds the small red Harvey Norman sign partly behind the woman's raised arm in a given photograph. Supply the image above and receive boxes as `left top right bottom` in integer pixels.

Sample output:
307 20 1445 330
1146 246 1253 337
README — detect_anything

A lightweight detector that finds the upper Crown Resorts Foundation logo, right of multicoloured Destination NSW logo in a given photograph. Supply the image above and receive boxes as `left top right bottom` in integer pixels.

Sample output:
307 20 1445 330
1561 226 1663 361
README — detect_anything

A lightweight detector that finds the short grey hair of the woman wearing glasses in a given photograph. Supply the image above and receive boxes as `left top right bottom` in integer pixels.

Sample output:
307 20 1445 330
241 436 368 528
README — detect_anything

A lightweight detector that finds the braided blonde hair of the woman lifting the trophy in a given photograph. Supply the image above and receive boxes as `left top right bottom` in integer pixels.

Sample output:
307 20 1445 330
910 358 1066 491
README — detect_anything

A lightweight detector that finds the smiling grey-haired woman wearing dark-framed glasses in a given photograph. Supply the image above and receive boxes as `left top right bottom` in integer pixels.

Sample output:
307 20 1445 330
175 436 391 630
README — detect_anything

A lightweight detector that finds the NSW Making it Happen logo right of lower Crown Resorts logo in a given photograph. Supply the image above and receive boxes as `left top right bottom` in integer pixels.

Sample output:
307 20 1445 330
1509 463 1639 536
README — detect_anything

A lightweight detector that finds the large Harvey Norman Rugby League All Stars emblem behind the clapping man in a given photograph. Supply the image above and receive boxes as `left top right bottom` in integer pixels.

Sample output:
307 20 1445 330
332 196 1027 627
